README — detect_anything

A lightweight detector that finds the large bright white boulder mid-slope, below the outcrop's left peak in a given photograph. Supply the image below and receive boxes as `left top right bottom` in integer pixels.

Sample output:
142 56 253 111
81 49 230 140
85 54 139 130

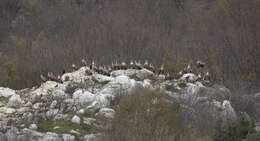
73 90 96 108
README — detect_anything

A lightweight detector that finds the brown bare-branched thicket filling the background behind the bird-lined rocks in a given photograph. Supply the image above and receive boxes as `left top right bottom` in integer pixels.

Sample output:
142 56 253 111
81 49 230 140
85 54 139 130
0 0 260 90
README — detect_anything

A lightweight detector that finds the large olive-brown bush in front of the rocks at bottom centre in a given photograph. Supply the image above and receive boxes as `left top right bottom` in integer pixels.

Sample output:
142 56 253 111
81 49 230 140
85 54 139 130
104 90 181 141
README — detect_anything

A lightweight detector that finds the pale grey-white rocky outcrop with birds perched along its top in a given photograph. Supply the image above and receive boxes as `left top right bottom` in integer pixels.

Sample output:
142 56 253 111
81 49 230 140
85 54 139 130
0 67 241 141
